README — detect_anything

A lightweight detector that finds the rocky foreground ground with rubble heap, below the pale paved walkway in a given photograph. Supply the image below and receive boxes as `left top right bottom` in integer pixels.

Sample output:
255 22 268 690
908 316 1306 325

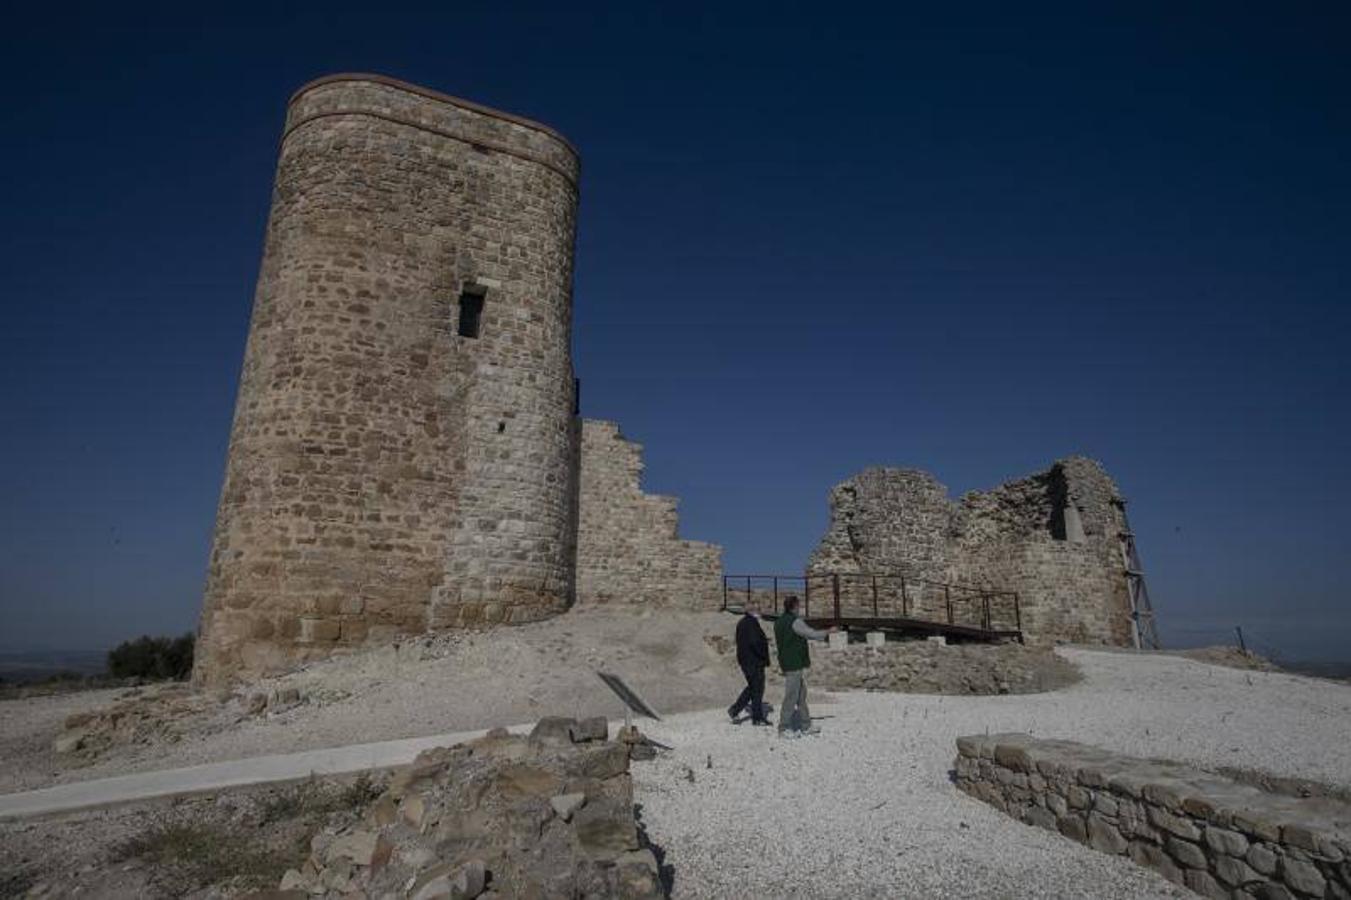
0 718 666 900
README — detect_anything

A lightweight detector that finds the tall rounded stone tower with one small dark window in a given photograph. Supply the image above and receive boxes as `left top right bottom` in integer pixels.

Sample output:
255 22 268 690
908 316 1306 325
196 74 578 681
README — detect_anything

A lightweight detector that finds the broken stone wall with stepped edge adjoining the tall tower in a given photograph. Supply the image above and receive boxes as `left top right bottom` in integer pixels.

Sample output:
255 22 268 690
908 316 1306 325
577 419 723 609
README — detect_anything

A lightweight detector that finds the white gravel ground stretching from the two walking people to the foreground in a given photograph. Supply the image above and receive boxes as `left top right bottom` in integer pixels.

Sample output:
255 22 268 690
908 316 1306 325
634 650 1351 899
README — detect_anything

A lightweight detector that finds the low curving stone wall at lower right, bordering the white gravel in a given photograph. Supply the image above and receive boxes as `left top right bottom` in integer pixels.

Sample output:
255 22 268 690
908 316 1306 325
957 734 1351 899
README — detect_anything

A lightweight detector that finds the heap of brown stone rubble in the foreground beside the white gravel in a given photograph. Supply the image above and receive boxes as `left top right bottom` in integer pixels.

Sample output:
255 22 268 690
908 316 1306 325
263 716 666 900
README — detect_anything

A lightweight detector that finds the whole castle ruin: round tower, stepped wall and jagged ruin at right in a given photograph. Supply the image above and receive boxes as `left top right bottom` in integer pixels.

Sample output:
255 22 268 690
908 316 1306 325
195 74 1151 682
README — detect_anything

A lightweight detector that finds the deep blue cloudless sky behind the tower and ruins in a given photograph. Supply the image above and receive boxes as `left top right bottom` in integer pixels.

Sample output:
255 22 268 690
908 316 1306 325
0 1 1351 657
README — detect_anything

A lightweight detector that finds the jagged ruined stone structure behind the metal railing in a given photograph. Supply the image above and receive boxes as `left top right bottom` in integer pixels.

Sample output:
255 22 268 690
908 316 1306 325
808 457 1131 645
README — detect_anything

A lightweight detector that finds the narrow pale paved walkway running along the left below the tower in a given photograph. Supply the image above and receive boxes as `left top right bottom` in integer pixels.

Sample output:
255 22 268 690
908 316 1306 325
0 726 530 819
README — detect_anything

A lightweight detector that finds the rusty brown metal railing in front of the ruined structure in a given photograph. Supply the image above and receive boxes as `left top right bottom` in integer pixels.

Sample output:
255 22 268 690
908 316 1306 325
723 572 1023 631
